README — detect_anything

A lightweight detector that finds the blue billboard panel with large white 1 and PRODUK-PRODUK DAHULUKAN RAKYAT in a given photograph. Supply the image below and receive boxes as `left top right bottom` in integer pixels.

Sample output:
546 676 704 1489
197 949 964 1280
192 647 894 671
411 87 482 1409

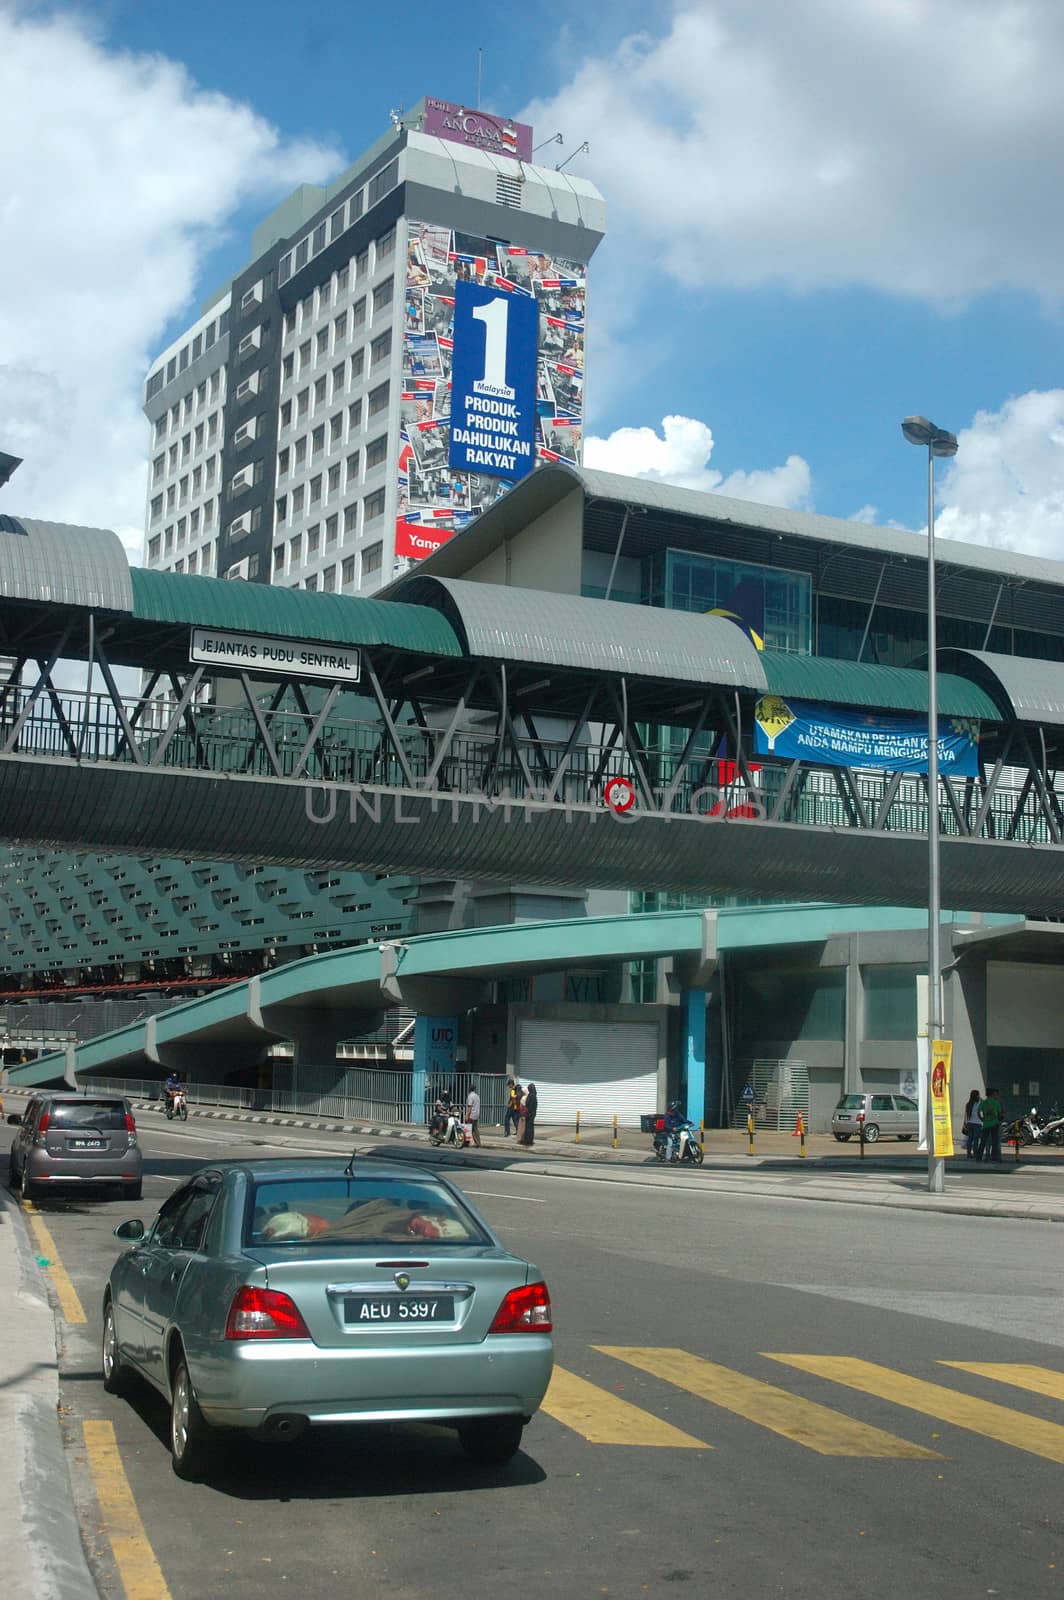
448 278 539 482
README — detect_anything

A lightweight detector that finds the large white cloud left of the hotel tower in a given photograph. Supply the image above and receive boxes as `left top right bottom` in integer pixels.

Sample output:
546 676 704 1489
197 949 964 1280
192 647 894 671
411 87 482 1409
0 5 341 558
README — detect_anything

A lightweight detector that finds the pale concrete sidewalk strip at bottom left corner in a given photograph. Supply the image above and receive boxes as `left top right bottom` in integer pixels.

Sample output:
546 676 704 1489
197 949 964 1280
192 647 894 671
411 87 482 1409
0 1189 98 1600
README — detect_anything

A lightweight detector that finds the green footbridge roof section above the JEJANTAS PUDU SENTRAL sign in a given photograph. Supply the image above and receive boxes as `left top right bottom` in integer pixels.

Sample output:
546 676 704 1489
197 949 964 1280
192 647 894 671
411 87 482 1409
130 566 462 656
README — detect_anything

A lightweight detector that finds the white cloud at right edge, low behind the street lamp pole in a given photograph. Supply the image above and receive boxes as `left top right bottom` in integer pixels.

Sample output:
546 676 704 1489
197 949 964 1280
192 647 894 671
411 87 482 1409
934 389 1064 562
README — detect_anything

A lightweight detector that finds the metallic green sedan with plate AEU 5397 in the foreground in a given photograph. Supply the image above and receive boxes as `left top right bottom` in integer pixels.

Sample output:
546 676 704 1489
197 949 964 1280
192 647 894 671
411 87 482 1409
102 1158 554 1478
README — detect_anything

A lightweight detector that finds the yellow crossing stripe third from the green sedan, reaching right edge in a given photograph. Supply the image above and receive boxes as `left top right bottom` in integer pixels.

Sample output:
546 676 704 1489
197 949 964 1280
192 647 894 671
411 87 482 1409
765 1350 1064 1462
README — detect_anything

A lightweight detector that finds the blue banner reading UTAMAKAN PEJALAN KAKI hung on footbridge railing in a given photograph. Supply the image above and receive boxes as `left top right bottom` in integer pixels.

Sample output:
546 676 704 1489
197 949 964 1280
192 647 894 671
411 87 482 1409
754 694 979 778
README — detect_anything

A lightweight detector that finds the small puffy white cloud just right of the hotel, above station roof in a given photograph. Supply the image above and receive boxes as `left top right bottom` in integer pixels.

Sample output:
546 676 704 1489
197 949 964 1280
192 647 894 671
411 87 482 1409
584 416 811 507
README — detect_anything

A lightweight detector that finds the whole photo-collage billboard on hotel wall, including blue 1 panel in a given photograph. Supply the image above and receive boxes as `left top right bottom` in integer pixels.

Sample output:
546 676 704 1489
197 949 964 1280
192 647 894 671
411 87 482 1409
395 221 587 560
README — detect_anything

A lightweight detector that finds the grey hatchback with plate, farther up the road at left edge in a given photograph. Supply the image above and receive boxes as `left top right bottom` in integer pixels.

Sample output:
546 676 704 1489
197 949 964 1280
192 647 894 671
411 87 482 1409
8 1090 144 1200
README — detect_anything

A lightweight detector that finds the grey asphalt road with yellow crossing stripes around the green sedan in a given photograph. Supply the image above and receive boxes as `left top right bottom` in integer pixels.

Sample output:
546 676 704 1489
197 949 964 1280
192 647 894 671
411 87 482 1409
3 1115 1064 1600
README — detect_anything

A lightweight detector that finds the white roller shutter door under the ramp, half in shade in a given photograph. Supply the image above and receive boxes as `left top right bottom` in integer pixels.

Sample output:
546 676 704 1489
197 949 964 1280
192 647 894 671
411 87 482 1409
517 1018 658 1128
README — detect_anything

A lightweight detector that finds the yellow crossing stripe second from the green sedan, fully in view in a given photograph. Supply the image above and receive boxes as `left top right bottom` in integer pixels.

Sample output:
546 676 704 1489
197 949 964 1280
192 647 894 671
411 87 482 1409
595 1344 942 1461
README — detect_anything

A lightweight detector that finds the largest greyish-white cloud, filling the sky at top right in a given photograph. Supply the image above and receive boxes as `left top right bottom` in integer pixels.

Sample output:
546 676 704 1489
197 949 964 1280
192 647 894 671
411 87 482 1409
526 0 1064 302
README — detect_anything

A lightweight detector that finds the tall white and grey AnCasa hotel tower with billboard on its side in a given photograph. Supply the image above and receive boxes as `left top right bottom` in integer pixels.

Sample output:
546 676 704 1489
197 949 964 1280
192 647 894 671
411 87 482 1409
144 99 605 594
